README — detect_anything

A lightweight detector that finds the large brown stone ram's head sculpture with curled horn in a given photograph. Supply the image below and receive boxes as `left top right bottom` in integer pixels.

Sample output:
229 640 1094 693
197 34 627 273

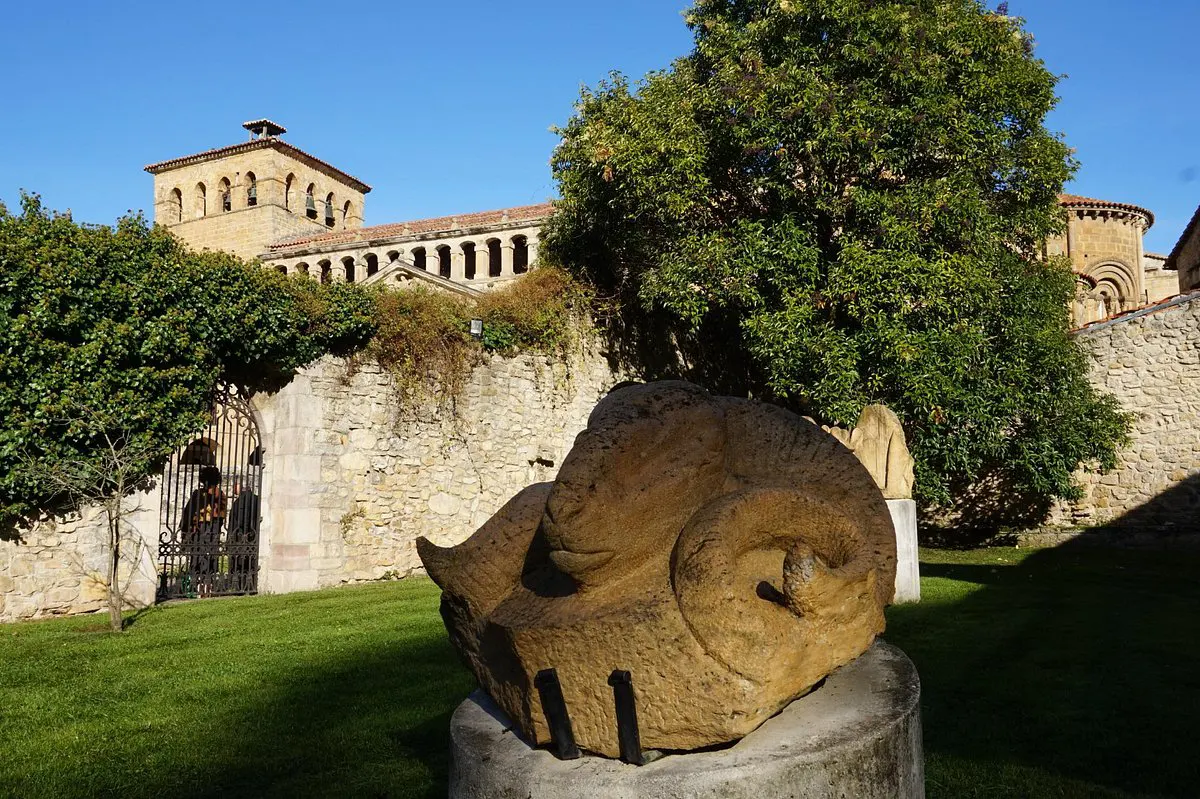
418 382 895 757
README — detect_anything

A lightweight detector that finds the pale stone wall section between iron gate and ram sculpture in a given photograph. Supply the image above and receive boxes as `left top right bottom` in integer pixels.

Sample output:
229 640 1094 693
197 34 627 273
259 345 618 591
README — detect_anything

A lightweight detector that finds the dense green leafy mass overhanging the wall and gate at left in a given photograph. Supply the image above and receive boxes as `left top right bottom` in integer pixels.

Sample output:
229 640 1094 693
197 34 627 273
0 196 374 527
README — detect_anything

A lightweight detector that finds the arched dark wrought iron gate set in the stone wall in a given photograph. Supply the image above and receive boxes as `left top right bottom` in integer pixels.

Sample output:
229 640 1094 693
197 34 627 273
158 385 263 601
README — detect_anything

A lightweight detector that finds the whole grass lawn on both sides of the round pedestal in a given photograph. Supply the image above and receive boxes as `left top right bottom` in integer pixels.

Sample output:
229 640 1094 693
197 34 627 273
0 547 1200 798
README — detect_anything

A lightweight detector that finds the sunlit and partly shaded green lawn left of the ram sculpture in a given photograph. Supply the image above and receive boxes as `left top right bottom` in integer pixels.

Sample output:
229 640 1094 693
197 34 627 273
0 581 474 798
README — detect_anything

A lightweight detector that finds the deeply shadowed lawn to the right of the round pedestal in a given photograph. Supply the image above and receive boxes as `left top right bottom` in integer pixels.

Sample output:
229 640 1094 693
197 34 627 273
887 545 1200 797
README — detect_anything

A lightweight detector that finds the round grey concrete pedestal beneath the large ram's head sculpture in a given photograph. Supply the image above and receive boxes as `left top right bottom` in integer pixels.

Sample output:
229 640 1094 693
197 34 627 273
450 642 925 799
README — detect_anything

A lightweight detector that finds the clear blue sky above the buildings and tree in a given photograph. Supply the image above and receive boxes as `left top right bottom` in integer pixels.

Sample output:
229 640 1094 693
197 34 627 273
0 0 1200 253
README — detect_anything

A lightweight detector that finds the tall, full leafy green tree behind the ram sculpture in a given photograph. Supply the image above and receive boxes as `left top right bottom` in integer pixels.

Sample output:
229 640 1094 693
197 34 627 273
545 0 1127 503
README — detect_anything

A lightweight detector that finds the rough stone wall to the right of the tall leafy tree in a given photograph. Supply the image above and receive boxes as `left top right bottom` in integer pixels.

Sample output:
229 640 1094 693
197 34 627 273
1051 294 1200 531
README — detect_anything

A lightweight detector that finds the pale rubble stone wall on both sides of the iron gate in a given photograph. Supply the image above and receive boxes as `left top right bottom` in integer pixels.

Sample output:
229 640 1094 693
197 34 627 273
0 349 620 621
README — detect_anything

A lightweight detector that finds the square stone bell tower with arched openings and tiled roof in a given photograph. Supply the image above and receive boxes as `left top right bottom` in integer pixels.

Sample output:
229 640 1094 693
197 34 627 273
145 119 371 258
